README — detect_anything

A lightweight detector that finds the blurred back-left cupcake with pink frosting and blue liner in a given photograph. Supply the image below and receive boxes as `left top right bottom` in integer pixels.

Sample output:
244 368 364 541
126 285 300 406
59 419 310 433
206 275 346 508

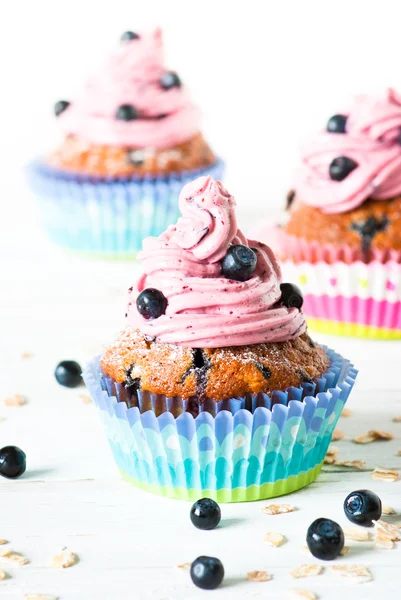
28 29 222 256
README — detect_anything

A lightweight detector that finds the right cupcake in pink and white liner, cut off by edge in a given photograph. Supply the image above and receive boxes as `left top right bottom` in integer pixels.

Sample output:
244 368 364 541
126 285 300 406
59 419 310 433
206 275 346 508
263 89 401 339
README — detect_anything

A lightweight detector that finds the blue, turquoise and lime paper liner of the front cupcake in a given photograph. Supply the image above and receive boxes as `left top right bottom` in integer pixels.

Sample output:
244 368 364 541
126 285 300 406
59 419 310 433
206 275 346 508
84 350 357 502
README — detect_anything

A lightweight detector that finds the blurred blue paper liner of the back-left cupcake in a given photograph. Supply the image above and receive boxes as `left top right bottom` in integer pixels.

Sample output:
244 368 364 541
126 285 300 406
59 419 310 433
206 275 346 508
28 160 224 258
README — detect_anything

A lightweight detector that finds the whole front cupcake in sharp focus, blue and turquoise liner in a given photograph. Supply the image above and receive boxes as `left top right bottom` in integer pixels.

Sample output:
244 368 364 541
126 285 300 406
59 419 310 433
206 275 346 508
84 176 356 502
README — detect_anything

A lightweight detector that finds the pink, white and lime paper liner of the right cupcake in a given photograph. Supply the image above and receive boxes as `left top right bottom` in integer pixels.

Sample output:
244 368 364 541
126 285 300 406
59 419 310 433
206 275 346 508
255 222 401 340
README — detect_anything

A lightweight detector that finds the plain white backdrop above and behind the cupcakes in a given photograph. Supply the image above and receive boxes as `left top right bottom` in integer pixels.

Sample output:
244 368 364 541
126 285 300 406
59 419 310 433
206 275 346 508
0 0 401 239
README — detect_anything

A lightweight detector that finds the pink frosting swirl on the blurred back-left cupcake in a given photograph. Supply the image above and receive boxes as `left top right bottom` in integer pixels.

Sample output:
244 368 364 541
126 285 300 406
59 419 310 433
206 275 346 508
58 29 200 148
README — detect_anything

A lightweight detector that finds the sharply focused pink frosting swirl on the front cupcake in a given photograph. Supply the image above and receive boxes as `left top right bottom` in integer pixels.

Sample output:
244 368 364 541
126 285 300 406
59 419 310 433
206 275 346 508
127 177 306 348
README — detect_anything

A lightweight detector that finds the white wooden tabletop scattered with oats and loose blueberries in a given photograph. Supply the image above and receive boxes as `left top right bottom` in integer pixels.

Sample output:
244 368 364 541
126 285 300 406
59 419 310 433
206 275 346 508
0 205 401 600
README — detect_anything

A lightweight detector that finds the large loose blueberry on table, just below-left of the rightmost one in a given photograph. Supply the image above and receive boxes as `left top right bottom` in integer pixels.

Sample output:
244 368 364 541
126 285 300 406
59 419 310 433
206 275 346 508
306 519 344 560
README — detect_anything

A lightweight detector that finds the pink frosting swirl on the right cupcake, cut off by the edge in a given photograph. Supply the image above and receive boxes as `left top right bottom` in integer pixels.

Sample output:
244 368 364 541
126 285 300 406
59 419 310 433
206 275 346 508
294 89 401 213
